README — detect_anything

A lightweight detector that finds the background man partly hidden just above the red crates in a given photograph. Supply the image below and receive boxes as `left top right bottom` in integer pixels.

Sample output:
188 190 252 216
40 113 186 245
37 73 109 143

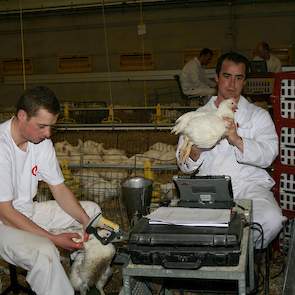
254 42 282 73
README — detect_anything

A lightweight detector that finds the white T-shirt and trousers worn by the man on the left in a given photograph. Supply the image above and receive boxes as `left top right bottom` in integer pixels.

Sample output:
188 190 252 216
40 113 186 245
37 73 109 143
0 120 101 295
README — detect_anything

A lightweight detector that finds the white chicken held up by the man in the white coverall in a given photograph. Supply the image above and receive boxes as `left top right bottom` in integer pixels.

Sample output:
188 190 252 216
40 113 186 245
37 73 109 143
171 98 237 163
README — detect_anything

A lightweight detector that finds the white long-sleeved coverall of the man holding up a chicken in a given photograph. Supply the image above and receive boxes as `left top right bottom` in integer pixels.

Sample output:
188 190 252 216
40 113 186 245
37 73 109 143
176 96 284 248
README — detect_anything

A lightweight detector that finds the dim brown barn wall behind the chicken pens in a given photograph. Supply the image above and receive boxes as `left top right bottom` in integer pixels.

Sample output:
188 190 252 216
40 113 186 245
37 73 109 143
0 1 295 106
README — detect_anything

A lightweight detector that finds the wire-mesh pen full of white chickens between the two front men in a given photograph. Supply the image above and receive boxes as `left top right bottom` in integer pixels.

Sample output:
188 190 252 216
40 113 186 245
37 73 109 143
37 131 182 229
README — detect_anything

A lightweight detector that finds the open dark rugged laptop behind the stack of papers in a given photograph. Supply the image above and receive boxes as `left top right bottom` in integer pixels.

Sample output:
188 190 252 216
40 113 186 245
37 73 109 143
173 175 234 209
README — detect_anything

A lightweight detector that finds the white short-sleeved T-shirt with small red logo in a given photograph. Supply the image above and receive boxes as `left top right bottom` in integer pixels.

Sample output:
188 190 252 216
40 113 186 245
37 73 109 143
0 119 64 218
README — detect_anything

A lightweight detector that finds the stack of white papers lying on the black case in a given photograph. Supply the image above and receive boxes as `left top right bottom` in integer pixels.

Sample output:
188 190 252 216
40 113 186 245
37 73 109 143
146 207 231 227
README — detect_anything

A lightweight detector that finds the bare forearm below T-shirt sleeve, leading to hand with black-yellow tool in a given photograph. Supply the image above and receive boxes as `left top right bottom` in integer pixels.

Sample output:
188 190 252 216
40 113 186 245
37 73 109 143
49 183 90 229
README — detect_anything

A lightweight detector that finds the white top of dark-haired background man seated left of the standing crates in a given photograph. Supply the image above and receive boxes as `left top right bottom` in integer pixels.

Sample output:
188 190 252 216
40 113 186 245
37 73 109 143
180 57 216 96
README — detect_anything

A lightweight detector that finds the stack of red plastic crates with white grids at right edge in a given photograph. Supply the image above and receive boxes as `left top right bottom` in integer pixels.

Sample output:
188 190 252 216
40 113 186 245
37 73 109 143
273 72 295 224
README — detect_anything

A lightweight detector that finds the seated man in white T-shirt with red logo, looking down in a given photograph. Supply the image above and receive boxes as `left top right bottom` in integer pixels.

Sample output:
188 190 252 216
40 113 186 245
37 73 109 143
0 87 100 295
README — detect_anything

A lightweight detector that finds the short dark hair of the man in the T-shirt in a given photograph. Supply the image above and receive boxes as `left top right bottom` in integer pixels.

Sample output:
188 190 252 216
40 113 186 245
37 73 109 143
16 86 60 118
